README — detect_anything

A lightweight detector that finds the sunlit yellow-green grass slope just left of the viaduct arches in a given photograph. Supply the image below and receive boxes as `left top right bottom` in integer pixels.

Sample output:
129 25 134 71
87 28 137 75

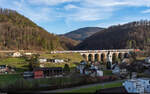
40 53 84 67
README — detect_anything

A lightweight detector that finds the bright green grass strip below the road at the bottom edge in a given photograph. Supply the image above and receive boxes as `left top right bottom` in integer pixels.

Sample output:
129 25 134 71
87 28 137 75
64 82 122 93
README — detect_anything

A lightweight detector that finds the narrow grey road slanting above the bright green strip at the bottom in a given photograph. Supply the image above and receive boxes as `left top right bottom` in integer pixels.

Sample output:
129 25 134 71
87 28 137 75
37 80 125 94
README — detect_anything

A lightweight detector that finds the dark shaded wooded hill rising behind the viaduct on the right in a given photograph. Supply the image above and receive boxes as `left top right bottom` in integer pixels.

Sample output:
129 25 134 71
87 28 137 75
76 20 150 50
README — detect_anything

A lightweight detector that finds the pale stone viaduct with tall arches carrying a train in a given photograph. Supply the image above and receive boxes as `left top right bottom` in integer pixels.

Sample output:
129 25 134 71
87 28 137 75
51 49 139 62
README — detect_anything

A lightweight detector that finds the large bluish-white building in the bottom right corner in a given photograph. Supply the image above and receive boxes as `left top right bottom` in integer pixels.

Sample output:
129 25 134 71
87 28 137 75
123 78 150 93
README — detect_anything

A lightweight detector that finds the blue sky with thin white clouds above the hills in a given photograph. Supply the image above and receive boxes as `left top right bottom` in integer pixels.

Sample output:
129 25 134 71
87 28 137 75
0 0 150 34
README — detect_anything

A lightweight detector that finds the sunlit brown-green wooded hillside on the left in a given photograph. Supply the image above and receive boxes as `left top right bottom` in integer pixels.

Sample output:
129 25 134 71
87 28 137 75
0 9 75 50
